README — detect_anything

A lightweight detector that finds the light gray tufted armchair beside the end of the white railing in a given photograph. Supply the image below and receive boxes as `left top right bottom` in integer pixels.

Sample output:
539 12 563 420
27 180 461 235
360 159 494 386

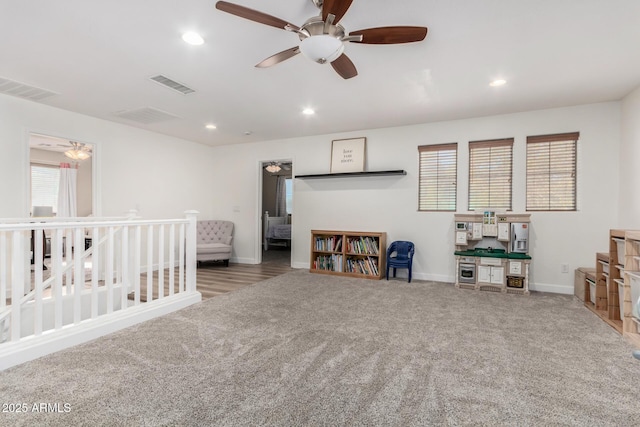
196 220 233 267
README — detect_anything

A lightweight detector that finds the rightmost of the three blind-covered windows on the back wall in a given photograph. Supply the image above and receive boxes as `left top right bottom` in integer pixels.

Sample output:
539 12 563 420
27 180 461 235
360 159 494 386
527 132 580 211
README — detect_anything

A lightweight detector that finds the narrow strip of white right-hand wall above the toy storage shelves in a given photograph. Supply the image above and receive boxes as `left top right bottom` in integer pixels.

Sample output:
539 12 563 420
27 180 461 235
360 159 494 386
619 86 640 230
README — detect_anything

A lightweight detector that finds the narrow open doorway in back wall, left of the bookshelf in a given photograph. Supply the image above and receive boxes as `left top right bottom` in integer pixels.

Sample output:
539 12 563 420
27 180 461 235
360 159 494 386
260 160 293 266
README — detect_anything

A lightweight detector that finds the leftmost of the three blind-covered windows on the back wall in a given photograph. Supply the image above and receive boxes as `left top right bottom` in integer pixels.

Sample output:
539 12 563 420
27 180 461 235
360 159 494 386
418 143 458 211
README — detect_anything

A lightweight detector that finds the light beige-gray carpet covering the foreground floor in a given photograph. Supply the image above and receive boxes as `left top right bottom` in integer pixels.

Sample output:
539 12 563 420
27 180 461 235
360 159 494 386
0 270 640 426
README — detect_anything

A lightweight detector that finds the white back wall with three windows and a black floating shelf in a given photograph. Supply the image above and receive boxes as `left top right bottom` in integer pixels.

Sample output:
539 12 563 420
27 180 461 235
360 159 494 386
214 102 620 293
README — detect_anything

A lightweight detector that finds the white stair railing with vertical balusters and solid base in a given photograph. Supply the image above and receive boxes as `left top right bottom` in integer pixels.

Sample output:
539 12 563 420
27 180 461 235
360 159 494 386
0 211 201 370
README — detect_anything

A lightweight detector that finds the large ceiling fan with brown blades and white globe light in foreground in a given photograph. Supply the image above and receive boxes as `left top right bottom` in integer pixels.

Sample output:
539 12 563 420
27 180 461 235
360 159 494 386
216 0 427 79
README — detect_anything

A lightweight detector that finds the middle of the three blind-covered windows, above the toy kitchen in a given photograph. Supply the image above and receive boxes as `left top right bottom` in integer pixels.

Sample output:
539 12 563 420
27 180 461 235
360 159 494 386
469 138 513 211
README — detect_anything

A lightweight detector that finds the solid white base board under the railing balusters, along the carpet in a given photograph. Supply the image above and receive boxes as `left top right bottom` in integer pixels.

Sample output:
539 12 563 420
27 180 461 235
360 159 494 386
0 292 202 371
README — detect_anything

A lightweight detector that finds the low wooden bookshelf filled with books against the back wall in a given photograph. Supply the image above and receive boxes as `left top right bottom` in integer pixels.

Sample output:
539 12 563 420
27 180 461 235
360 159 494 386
309 230 387 280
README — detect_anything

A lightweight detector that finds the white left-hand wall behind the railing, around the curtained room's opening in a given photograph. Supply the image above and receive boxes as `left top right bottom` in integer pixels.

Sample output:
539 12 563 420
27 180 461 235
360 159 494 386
0 95 216 218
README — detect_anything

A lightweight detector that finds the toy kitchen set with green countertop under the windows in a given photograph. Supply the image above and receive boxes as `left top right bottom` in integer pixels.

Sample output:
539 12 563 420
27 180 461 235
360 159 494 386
454 211 531 295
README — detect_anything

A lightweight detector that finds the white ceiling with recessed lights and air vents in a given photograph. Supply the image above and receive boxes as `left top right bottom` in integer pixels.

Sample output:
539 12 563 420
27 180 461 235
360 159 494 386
0 0 640 145
